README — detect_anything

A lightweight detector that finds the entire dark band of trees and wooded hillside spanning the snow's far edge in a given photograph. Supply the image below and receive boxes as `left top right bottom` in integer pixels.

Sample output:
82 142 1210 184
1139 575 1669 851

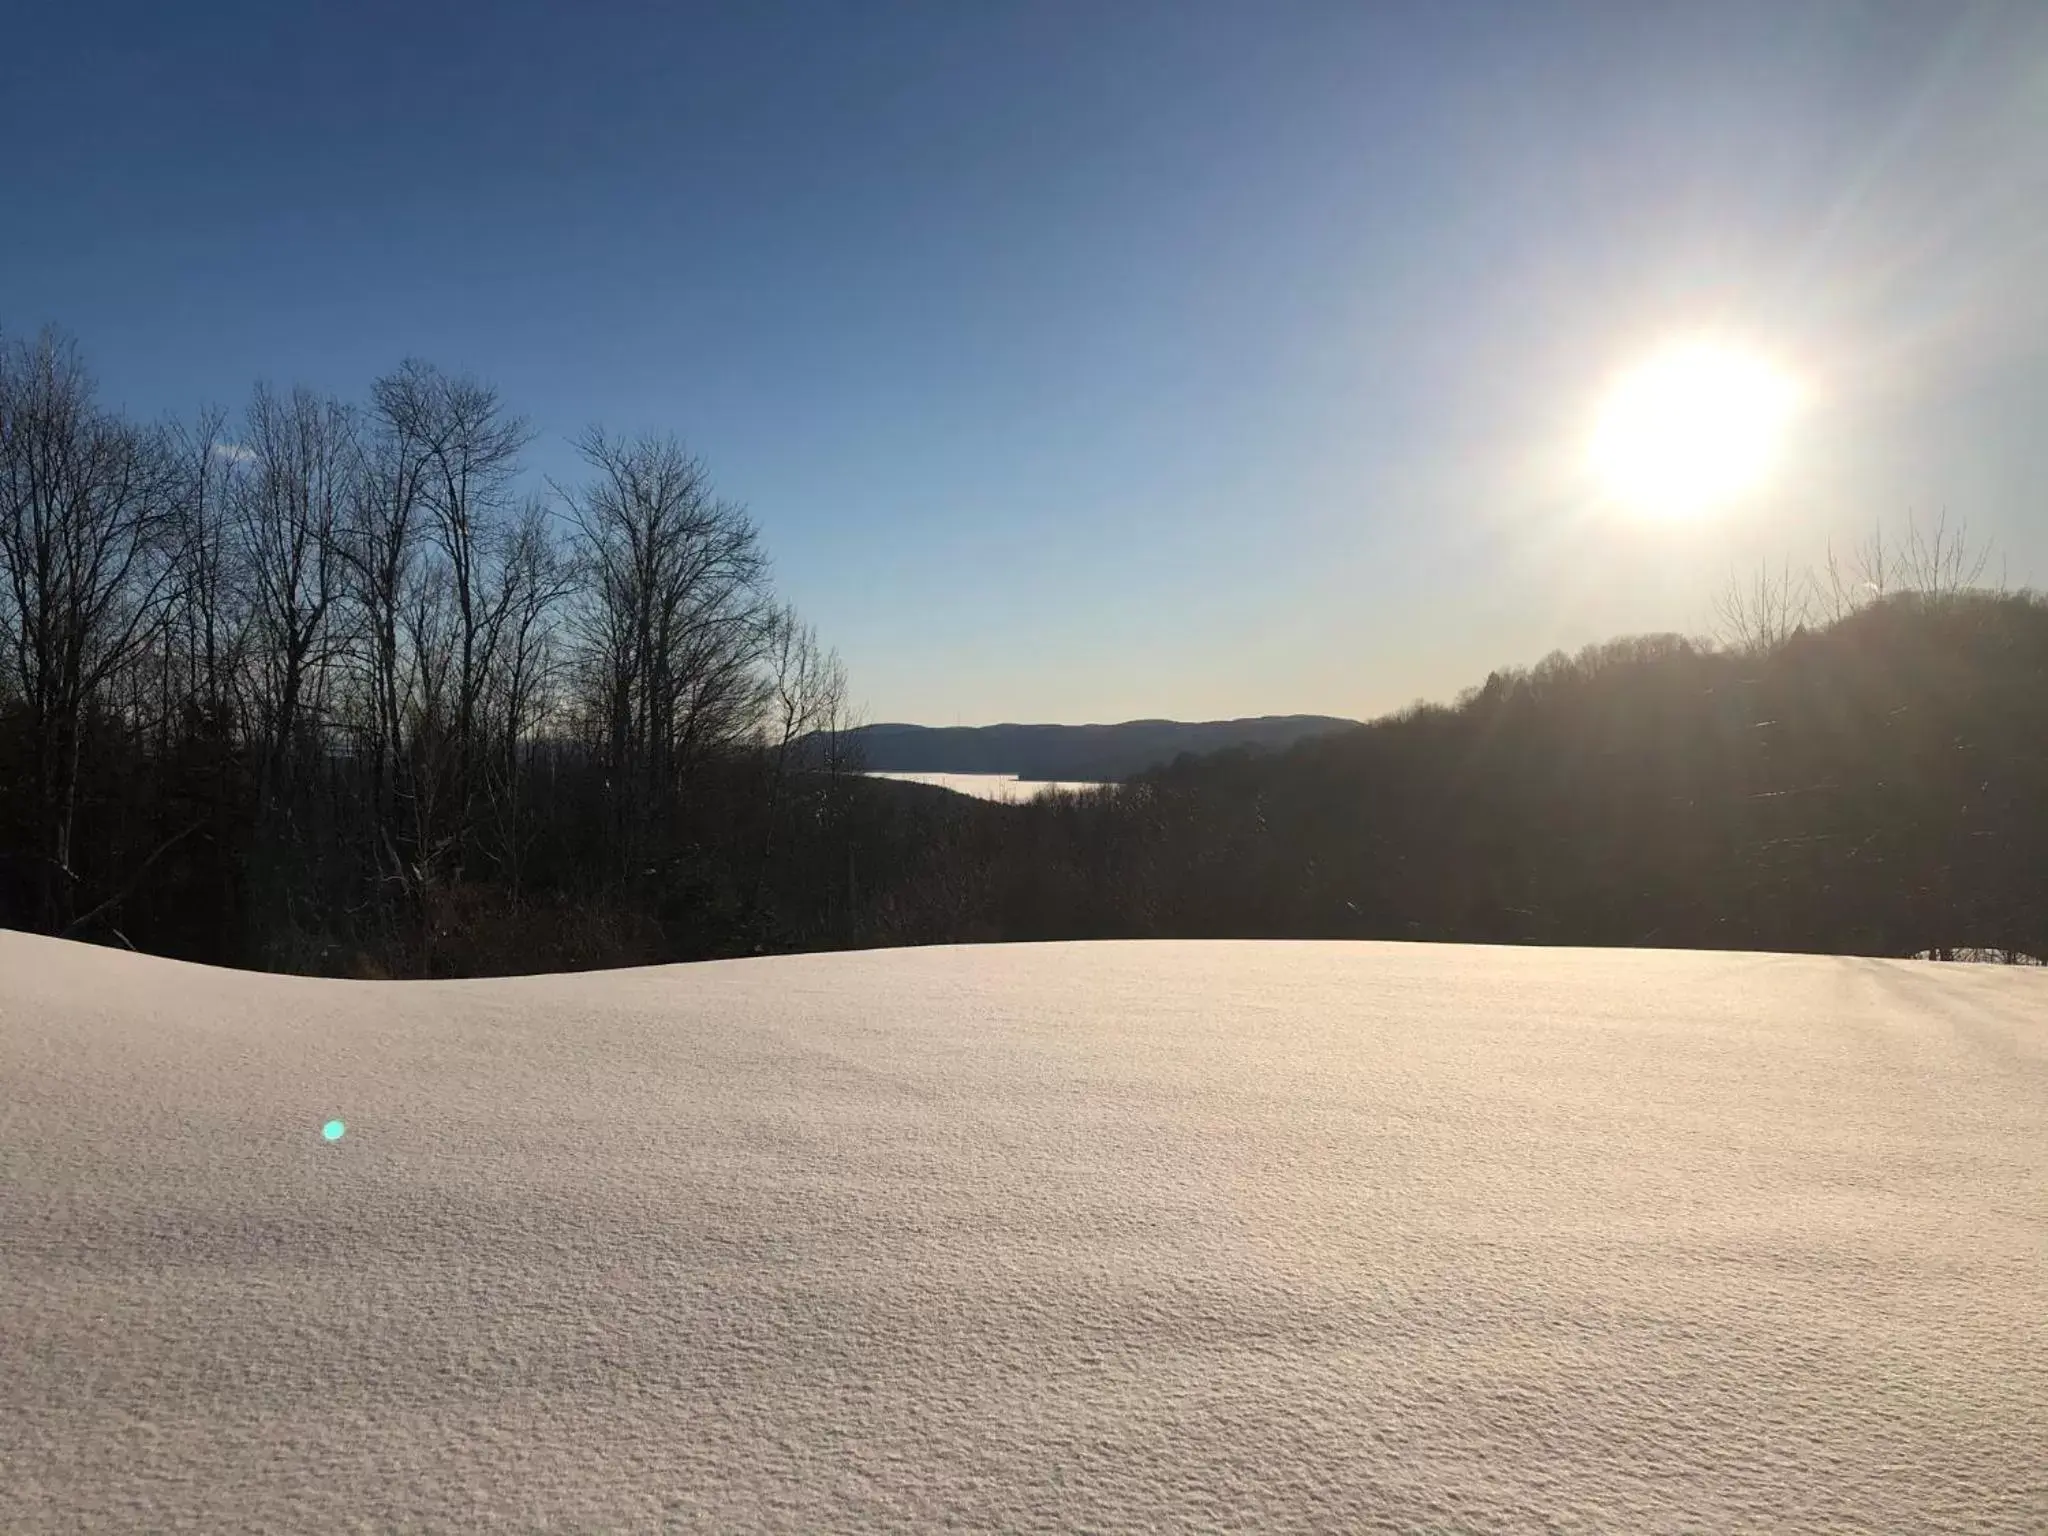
0 323 2048 975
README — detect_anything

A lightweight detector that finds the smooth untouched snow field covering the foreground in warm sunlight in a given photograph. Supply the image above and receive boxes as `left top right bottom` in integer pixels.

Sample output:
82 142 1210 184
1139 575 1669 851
0 934 2048 1532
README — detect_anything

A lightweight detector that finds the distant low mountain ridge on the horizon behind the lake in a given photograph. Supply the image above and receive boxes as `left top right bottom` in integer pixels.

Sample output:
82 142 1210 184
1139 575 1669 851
831 715 1358 780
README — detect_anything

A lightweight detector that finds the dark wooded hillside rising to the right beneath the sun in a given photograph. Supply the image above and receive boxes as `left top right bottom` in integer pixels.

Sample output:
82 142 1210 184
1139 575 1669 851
872 590 2048 956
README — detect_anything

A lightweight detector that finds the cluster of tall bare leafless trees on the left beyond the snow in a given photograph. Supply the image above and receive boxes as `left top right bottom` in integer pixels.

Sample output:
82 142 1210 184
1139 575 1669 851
0 332 852 975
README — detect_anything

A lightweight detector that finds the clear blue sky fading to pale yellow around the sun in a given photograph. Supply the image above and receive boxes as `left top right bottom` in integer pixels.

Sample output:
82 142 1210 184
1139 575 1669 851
0 0 2048 723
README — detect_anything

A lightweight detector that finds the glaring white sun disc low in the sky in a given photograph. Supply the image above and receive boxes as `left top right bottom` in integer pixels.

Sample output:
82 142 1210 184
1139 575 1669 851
1589 340 1800 518
